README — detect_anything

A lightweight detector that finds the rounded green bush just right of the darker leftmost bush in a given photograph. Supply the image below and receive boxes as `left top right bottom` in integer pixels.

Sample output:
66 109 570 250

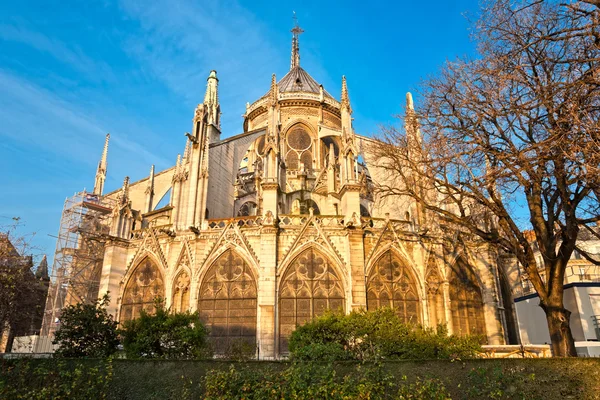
122 302 210 359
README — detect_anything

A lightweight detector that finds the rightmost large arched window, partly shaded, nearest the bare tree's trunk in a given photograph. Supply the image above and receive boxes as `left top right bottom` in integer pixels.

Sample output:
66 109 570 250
450 258 485 335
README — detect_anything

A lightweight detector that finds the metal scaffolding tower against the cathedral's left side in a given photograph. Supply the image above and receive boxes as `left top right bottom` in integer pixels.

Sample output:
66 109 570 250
41 191 114 337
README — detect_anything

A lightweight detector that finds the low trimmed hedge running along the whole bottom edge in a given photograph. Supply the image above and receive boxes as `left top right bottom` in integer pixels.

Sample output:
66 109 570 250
0 358 600 400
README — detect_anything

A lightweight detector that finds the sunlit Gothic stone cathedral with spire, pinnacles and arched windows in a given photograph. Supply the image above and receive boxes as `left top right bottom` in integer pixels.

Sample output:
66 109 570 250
83 26 513 359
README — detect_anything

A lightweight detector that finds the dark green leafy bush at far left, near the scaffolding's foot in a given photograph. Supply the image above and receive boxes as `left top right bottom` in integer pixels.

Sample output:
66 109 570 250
53 295 119 357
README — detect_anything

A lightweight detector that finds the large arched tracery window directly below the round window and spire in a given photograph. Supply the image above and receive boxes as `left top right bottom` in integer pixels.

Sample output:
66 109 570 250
279 248 344 353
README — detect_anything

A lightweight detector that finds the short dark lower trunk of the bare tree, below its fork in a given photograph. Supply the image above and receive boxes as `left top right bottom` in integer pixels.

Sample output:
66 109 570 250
540 304 577 357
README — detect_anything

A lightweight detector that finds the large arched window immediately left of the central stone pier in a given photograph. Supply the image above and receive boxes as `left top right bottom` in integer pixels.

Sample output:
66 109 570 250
198 250 257 354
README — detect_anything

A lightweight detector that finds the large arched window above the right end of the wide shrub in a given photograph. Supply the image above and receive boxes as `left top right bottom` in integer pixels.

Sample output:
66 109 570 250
367 250 421 324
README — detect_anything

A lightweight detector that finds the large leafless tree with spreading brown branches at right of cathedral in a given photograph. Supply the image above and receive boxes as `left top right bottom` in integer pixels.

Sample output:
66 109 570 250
372 0 600 356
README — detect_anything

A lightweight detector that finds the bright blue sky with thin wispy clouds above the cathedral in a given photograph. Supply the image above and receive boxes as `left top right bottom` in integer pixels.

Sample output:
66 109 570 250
0 0 478 268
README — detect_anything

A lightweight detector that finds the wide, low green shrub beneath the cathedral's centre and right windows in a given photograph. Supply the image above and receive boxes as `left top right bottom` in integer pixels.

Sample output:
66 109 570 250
289 308 481 360
